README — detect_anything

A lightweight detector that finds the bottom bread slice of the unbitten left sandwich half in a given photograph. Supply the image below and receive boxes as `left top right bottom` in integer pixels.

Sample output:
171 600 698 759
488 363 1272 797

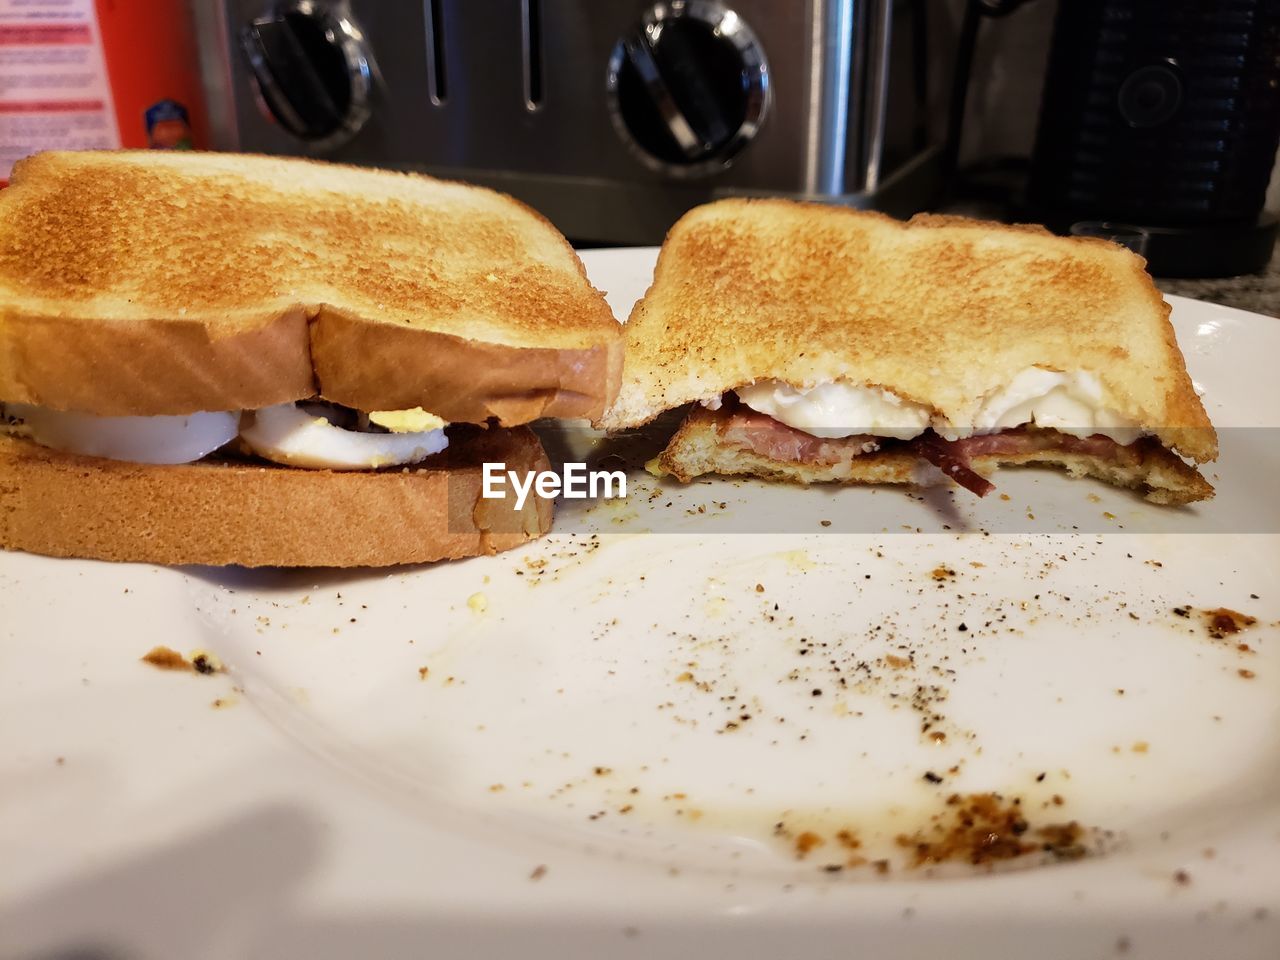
0 428 552 567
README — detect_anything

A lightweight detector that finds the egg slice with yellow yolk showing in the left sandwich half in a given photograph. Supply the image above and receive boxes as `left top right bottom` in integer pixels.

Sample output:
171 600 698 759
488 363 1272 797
241 403 449 470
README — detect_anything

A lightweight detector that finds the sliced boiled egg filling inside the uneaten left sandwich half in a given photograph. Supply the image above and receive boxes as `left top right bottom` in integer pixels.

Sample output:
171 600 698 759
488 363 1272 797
0 402 449 470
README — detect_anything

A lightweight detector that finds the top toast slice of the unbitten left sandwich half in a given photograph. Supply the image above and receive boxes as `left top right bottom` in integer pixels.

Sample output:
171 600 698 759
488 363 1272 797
0 151 622 425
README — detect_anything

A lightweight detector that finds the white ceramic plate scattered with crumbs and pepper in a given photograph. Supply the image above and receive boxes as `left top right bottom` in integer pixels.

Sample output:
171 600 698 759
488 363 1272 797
0 251 1280 960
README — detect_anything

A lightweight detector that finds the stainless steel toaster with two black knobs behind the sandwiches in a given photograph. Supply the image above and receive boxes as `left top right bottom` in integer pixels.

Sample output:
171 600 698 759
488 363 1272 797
197 0 937 243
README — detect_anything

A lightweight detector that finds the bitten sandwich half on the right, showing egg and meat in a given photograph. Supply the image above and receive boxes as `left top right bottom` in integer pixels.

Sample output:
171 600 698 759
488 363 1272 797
598 200 1217 504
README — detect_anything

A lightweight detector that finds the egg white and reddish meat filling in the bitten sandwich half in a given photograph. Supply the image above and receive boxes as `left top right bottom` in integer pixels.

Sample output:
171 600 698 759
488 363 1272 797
705 367 1149 497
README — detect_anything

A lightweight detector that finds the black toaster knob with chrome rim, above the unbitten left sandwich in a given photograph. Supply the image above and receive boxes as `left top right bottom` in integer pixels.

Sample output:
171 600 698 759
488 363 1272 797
241 0 372 148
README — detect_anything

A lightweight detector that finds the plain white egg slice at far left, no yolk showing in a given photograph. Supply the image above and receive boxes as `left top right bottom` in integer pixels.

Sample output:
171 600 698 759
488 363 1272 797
4 403 239 463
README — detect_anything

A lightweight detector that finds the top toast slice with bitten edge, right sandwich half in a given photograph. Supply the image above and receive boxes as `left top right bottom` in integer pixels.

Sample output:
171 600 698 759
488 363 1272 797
598 200 1217 462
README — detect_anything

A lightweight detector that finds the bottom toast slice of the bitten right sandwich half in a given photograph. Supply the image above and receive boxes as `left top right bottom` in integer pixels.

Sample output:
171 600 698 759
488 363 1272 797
650 407 1213 506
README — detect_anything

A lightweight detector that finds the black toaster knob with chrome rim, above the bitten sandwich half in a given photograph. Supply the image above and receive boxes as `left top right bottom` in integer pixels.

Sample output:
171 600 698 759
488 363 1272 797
607 0 769 177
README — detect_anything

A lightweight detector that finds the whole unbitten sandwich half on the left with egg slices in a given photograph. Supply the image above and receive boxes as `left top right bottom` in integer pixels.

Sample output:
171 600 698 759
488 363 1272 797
0 151 622 567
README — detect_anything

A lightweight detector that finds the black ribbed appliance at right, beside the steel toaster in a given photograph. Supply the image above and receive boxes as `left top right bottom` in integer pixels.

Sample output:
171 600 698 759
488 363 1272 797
1029 0 1280 276
